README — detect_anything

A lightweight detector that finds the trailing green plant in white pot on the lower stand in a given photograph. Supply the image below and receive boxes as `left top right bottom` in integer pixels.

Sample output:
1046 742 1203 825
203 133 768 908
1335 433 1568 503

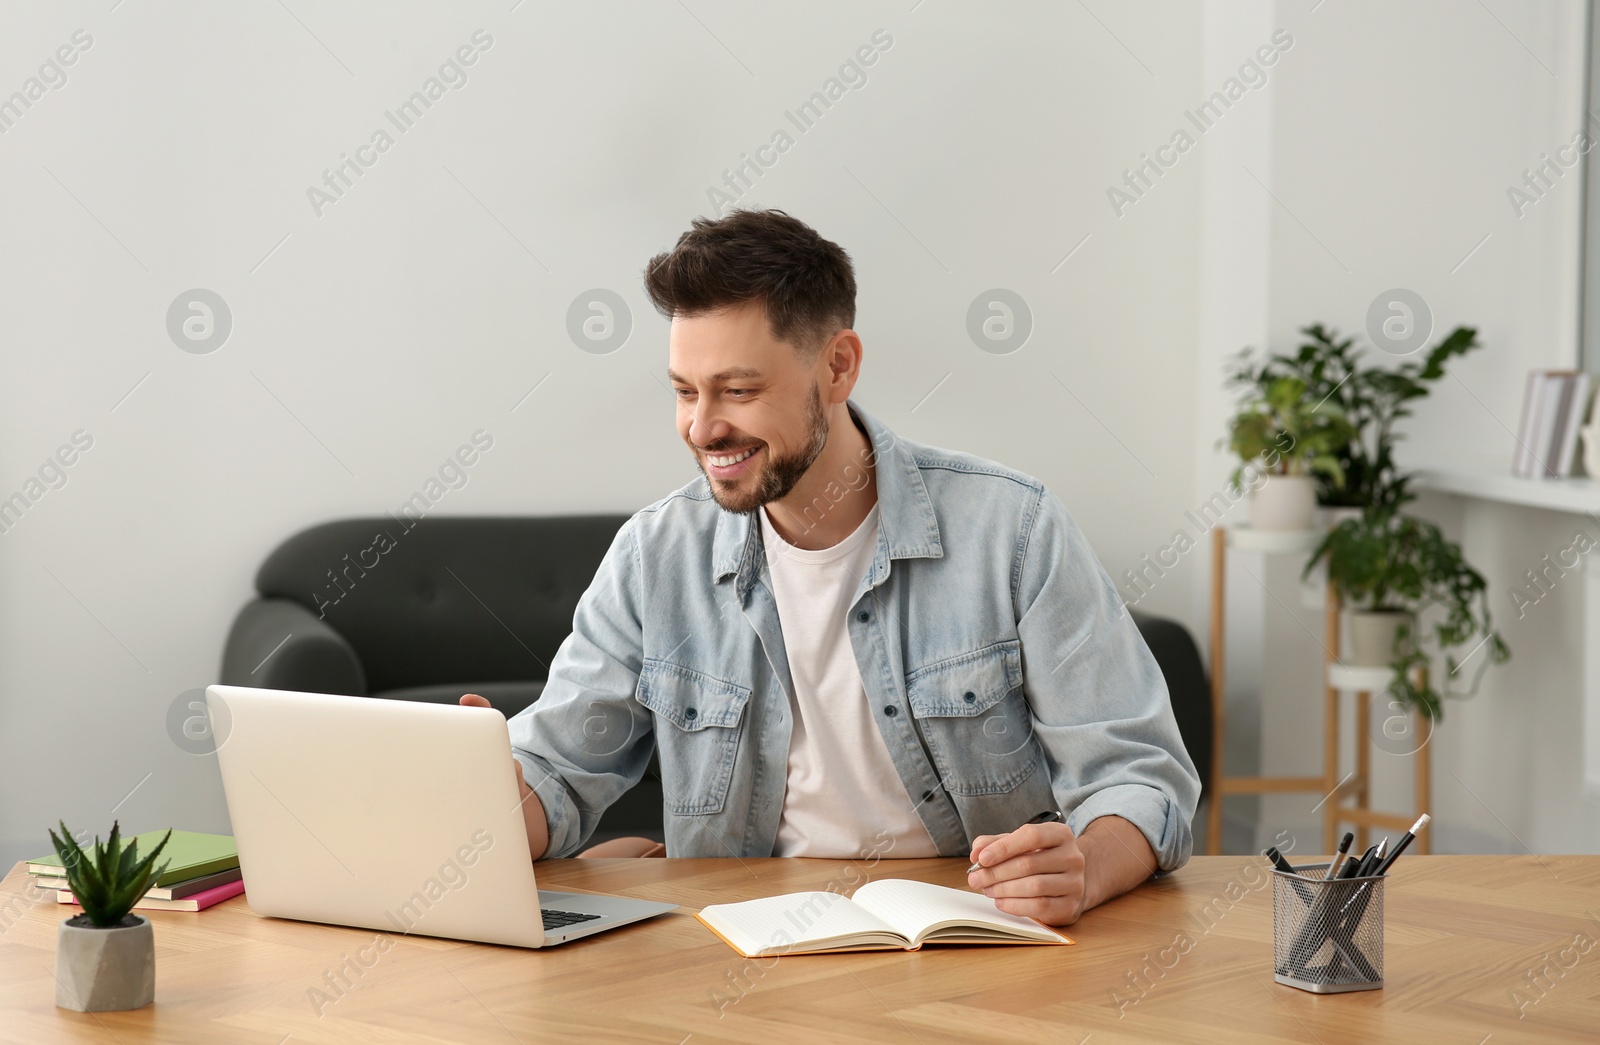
1306 507 1510 719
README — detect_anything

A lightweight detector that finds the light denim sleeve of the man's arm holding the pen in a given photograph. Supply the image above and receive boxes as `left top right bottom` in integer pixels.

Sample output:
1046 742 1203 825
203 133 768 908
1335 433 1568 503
1016 488 1200 871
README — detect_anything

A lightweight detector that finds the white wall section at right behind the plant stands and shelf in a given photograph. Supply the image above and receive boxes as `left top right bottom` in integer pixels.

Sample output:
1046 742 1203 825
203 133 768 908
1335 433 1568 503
1262 0 1600 853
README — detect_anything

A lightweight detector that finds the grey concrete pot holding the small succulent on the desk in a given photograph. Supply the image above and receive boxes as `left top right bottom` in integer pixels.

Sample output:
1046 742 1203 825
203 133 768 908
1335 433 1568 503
56 914 155 1013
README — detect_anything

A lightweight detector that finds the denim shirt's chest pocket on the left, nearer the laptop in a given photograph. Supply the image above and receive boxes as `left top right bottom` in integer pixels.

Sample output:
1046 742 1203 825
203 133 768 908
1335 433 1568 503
638 661 750 816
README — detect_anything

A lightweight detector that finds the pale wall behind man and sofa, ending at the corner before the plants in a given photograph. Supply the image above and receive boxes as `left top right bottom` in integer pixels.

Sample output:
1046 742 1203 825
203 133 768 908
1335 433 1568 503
0 0 1210 866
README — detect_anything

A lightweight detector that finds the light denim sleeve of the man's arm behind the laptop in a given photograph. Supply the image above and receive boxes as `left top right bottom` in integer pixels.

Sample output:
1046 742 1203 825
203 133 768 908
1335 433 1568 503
507 518 654 856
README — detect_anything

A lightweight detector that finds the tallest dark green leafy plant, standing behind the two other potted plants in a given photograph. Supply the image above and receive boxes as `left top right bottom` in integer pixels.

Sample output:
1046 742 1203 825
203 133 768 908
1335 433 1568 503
1256 323 1482 509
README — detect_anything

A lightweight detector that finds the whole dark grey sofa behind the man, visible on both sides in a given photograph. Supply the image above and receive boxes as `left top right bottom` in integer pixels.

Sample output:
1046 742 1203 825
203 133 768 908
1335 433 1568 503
221 515 1211 842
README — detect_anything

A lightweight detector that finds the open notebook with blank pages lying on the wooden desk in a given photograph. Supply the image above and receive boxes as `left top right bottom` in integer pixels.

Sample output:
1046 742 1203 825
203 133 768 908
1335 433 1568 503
698 879 1072 959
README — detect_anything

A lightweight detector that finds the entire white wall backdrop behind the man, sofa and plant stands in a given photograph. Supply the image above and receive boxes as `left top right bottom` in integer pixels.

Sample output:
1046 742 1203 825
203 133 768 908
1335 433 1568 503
0 0 1600 866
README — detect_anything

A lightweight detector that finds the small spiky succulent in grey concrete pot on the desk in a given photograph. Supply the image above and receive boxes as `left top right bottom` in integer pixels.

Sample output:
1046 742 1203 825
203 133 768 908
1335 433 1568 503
50 821 173 1013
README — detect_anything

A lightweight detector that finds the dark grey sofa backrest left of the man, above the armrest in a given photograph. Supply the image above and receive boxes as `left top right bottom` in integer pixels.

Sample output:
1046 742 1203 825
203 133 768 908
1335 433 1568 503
256 515 629 693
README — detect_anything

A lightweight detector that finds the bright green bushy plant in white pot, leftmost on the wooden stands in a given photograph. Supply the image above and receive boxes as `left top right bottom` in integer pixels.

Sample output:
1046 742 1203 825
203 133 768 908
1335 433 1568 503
1227 364 1355 530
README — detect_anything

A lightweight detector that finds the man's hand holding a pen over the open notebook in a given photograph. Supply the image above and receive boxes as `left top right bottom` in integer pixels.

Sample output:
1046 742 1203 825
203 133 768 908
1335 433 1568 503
966 816 1157 925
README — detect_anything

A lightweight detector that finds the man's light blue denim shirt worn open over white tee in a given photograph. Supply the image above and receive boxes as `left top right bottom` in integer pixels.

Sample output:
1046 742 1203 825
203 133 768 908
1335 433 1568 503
509 402 1200 871
